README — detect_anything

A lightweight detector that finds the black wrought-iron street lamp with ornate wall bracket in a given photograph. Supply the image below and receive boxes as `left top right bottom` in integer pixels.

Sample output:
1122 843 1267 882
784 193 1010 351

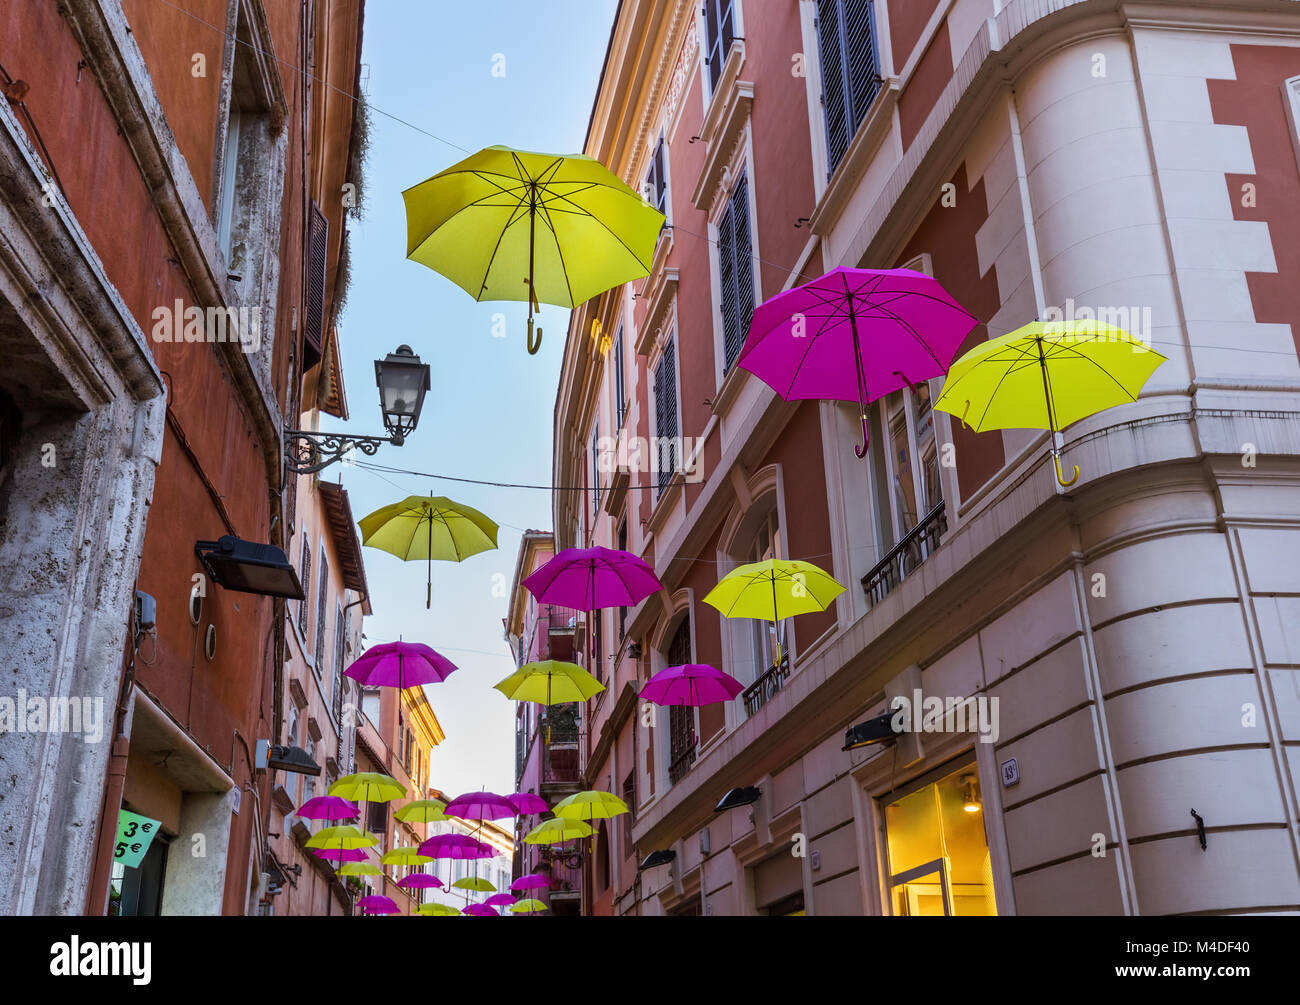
285 346 429 475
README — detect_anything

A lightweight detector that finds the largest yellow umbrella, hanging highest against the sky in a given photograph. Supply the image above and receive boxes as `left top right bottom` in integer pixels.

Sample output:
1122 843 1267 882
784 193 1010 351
402 147 664 354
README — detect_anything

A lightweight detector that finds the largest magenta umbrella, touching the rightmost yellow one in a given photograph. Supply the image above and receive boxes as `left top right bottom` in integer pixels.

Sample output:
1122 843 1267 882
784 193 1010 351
737 269 979 458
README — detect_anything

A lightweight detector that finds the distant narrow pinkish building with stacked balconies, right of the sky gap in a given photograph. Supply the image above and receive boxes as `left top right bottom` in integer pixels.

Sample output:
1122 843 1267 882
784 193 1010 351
504 530 585 915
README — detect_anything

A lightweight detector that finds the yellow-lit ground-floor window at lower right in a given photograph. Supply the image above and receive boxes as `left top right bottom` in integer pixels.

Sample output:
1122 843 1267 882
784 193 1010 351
884 763 997 917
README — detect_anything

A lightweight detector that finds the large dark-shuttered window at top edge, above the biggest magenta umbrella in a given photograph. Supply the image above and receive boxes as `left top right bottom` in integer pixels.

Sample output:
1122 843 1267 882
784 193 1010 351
816 0 881 176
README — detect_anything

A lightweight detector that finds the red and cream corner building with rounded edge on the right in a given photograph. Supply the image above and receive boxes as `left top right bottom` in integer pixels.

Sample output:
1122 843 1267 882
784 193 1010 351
554 0 1300 915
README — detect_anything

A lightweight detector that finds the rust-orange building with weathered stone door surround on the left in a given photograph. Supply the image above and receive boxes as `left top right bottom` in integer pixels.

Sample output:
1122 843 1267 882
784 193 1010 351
0 0 361 914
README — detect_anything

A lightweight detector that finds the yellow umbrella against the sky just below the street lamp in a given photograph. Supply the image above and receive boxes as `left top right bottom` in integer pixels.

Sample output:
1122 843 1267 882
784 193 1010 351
358 495 497 603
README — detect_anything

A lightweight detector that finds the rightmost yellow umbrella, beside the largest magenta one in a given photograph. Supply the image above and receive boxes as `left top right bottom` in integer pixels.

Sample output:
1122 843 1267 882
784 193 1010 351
935 320 1165 485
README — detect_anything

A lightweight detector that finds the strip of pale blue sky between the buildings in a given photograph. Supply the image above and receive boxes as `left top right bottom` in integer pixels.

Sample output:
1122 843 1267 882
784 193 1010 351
324 0 616 794
